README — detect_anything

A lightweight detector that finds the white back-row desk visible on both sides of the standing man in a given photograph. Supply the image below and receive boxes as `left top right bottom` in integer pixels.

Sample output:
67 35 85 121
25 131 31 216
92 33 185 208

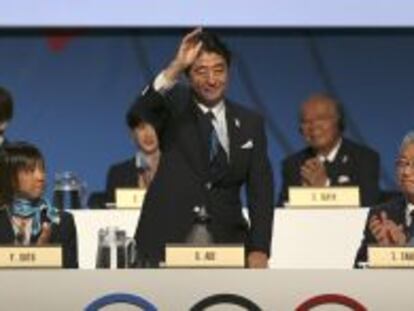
71 208 368 269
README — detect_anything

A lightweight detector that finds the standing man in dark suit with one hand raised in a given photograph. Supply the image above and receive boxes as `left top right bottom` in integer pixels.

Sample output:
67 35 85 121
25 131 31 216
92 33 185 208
136 29 273 267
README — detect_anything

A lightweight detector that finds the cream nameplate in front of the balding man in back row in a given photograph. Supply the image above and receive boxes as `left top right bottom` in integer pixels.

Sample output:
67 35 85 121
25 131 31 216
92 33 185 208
286 187 360 208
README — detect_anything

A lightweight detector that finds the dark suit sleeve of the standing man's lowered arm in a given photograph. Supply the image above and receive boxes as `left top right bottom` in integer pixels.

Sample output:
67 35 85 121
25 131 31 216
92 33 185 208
246 118 274 255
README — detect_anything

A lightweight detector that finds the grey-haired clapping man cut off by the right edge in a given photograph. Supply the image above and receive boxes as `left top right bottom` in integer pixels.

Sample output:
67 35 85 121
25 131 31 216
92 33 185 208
356 132 414 262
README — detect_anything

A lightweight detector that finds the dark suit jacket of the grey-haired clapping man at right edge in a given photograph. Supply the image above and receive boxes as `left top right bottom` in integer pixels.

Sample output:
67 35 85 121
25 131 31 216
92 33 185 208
355 196 407 264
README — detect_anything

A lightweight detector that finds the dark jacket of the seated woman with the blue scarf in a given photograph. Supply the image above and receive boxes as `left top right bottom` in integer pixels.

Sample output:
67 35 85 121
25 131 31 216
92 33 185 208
0 209 78 268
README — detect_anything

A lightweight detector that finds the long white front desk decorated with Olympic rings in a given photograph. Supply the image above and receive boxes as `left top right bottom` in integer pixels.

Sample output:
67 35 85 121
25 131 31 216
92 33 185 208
0 269 414 311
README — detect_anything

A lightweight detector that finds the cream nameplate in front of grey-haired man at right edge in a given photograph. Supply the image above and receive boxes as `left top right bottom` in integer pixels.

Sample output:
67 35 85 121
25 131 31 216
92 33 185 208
368 246 414 268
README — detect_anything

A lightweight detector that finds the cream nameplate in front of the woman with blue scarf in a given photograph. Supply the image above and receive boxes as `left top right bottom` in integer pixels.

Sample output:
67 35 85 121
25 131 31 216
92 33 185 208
0 246 62 268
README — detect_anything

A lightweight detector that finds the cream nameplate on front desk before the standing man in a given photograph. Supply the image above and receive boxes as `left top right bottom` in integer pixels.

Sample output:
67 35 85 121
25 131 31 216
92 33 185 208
165 244 245 268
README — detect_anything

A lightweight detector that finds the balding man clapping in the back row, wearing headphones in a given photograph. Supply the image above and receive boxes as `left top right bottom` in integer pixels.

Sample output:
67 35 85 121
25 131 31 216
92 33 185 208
279 93 379 206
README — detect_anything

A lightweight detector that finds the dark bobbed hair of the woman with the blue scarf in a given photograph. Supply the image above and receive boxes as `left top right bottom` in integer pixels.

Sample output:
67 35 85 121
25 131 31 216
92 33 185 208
0 142 45 206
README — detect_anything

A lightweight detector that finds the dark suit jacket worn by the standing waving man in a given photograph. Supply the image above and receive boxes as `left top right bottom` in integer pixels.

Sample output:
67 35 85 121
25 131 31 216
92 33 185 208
135 86 274 261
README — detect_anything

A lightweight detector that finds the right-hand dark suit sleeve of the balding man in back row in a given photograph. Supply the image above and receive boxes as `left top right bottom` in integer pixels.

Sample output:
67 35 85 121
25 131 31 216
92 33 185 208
359 152 380 207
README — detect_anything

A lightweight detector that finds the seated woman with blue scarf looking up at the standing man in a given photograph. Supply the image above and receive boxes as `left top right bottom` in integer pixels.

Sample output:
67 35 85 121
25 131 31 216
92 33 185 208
0 142 78 268
